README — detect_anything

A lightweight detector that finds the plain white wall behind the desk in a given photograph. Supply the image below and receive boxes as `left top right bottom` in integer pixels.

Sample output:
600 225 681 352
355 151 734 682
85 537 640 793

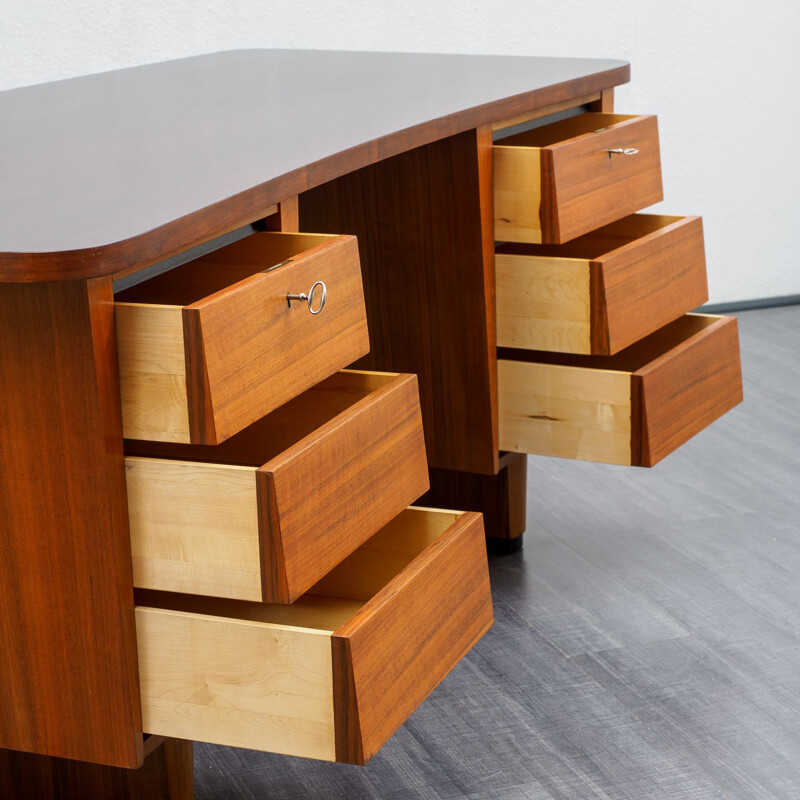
6 0 800 302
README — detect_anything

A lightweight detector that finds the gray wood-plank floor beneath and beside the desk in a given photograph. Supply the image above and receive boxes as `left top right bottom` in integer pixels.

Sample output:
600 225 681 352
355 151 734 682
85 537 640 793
196 306 800 800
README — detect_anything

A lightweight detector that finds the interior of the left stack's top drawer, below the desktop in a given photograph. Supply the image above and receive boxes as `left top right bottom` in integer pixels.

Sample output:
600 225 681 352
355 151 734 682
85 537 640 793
114 232 336 306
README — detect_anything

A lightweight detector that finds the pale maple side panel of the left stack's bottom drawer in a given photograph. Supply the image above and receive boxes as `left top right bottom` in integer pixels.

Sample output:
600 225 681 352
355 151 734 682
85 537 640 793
136 606 335 761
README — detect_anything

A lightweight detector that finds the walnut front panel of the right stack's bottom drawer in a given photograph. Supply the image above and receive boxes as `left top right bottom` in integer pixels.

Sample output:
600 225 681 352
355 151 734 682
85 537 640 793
632 316 743 467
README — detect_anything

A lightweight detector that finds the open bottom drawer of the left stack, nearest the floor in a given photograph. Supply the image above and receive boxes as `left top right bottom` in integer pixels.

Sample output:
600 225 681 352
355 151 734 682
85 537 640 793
136 508 492 764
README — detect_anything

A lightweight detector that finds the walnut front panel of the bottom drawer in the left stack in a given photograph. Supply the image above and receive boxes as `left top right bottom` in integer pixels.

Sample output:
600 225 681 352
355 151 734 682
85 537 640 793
331 513 492 764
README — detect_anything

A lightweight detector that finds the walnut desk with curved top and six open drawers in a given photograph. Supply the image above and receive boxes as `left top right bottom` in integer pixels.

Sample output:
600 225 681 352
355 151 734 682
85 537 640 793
0 51 741 798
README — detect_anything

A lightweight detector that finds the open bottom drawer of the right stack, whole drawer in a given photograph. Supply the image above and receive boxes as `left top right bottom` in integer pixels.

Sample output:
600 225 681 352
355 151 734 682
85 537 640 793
497 314 742 467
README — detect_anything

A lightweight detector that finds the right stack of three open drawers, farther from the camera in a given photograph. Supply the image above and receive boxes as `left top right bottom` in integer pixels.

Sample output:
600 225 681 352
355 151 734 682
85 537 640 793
494 112 742 466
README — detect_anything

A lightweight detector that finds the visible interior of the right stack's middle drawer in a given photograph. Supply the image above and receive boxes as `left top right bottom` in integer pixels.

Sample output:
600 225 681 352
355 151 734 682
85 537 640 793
496 214 686 261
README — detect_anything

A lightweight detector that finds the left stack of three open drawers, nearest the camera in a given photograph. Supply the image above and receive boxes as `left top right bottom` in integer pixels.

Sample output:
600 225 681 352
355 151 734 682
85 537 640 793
116 225 492 764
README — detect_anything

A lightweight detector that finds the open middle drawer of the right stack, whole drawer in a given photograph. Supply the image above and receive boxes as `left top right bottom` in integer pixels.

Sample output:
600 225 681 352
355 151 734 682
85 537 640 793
495 214 708 355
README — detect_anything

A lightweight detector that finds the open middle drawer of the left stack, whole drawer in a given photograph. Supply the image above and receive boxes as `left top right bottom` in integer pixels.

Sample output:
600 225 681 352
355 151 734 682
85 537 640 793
125 372 428 603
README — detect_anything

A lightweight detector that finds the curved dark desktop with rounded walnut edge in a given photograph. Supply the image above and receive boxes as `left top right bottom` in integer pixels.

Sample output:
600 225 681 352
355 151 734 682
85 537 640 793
0 50 629 281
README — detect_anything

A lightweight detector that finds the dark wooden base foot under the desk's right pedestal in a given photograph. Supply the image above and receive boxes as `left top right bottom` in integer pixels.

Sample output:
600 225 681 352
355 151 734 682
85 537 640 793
418 453 528 553
